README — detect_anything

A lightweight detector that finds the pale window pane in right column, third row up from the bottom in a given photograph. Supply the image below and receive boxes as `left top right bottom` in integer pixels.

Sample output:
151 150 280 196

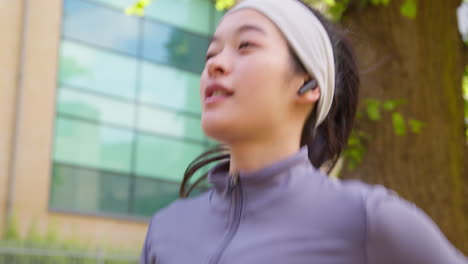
138 106 204 142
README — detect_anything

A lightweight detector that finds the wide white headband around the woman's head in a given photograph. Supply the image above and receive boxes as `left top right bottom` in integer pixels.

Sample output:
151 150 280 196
228 0 335 127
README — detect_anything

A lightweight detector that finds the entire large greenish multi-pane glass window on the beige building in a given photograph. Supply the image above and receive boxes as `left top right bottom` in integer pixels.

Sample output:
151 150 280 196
50 0 218 216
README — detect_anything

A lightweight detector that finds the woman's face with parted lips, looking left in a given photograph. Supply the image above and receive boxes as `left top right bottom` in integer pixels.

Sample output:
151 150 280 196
200 9 307 144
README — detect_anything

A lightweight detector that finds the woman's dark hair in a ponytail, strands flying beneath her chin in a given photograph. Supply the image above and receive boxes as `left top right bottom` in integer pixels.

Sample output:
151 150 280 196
179 0 359 197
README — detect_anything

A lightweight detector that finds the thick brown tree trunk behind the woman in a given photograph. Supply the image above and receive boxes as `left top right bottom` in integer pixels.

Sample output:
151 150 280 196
343 0 468 254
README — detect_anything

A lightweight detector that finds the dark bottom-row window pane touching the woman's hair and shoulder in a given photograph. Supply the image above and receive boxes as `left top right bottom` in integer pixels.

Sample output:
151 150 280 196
134 177 179 216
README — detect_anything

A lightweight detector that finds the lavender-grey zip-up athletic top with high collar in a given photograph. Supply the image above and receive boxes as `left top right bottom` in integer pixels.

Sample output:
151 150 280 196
140 147 468 264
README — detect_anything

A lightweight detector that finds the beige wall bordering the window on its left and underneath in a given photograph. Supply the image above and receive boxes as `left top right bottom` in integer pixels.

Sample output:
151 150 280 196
0 0 147 252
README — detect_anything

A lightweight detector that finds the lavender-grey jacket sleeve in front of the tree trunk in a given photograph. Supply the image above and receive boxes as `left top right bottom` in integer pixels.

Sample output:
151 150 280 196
366 188 468 264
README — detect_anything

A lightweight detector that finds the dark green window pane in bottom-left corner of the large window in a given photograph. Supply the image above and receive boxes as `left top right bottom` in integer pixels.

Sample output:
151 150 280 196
50 164 130 214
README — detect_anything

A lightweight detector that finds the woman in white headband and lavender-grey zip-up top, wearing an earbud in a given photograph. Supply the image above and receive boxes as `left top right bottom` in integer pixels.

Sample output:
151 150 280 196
141 0 468 264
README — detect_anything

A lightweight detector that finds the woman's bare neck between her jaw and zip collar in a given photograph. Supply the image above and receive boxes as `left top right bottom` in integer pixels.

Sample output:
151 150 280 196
229 131 300 175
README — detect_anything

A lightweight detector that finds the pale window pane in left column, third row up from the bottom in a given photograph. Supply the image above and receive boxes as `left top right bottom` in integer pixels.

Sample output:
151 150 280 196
57 87 134 127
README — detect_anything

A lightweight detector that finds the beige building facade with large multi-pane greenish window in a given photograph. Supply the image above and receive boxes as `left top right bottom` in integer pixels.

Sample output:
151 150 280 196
0 0 222 248
